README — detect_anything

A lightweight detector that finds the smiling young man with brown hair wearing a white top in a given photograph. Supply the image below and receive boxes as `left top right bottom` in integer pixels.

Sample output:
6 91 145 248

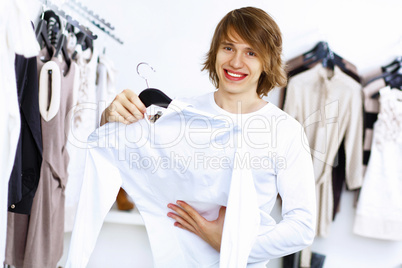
101 7 316 267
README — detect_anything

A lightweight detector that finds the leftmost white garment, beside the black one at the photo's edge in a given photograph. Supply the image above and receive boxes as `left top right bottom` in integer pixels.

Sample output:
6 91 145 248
0 0 39 263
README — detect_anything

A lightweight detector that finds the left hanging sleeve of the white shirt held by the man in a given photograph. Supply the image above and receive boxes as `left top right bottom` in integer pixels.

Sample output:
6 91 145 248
65 128 122 268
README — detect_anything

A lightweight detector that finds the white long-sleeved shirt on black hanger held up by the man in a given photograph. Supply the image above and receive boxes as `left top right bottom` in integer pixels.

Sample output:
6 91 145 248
66 101 260 268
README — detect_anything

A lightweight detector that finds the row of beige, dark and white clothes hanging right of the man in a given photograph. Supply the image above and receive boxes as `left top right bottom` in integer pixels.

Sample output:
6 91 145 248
280 42 402 267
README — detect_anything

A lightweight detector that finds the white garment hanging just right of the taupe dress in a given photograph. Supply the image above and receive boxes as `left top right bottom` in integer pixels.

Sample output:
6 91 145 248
64 47 98 232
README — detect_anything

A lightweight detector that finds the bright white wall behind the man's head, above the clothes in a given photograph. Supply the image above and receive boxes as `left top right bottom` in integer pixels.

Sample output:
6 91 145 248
83 0 402 99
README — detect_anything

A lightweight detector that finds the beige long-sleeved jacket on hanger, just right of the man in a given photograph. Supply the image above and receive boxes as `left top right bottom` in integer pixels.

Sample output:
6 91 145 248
282 42 363 267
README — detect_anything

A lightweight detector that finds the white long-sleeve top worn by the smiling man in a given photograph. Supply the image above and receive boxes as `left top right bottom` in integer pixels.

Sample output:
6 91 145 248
185 92 316 267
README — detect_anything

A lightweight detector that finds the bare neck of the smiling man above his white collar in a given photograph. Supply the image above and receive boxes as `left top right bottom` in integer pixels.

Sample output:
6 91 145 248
214 89 267 114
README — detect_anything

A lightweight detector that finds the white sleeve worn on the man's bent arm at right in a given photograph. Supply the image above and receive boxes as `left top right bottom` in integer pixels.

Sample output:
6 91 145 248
248 124 316 263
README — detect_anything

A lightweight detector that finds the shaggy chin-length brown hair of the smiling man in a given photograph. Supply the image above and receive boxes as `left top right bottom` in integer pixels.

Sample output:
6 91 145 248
202 7 287 97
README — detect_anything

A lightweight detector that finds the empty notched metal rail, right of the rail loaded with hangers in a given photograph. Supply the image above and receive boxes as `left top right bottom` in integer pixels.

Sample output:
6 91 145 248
66 0 123 45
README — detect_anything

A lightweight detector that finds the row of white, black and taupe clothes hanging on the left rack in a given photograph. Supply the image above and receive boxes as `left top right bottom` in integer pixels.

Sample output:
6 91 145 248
0 4 121 268
